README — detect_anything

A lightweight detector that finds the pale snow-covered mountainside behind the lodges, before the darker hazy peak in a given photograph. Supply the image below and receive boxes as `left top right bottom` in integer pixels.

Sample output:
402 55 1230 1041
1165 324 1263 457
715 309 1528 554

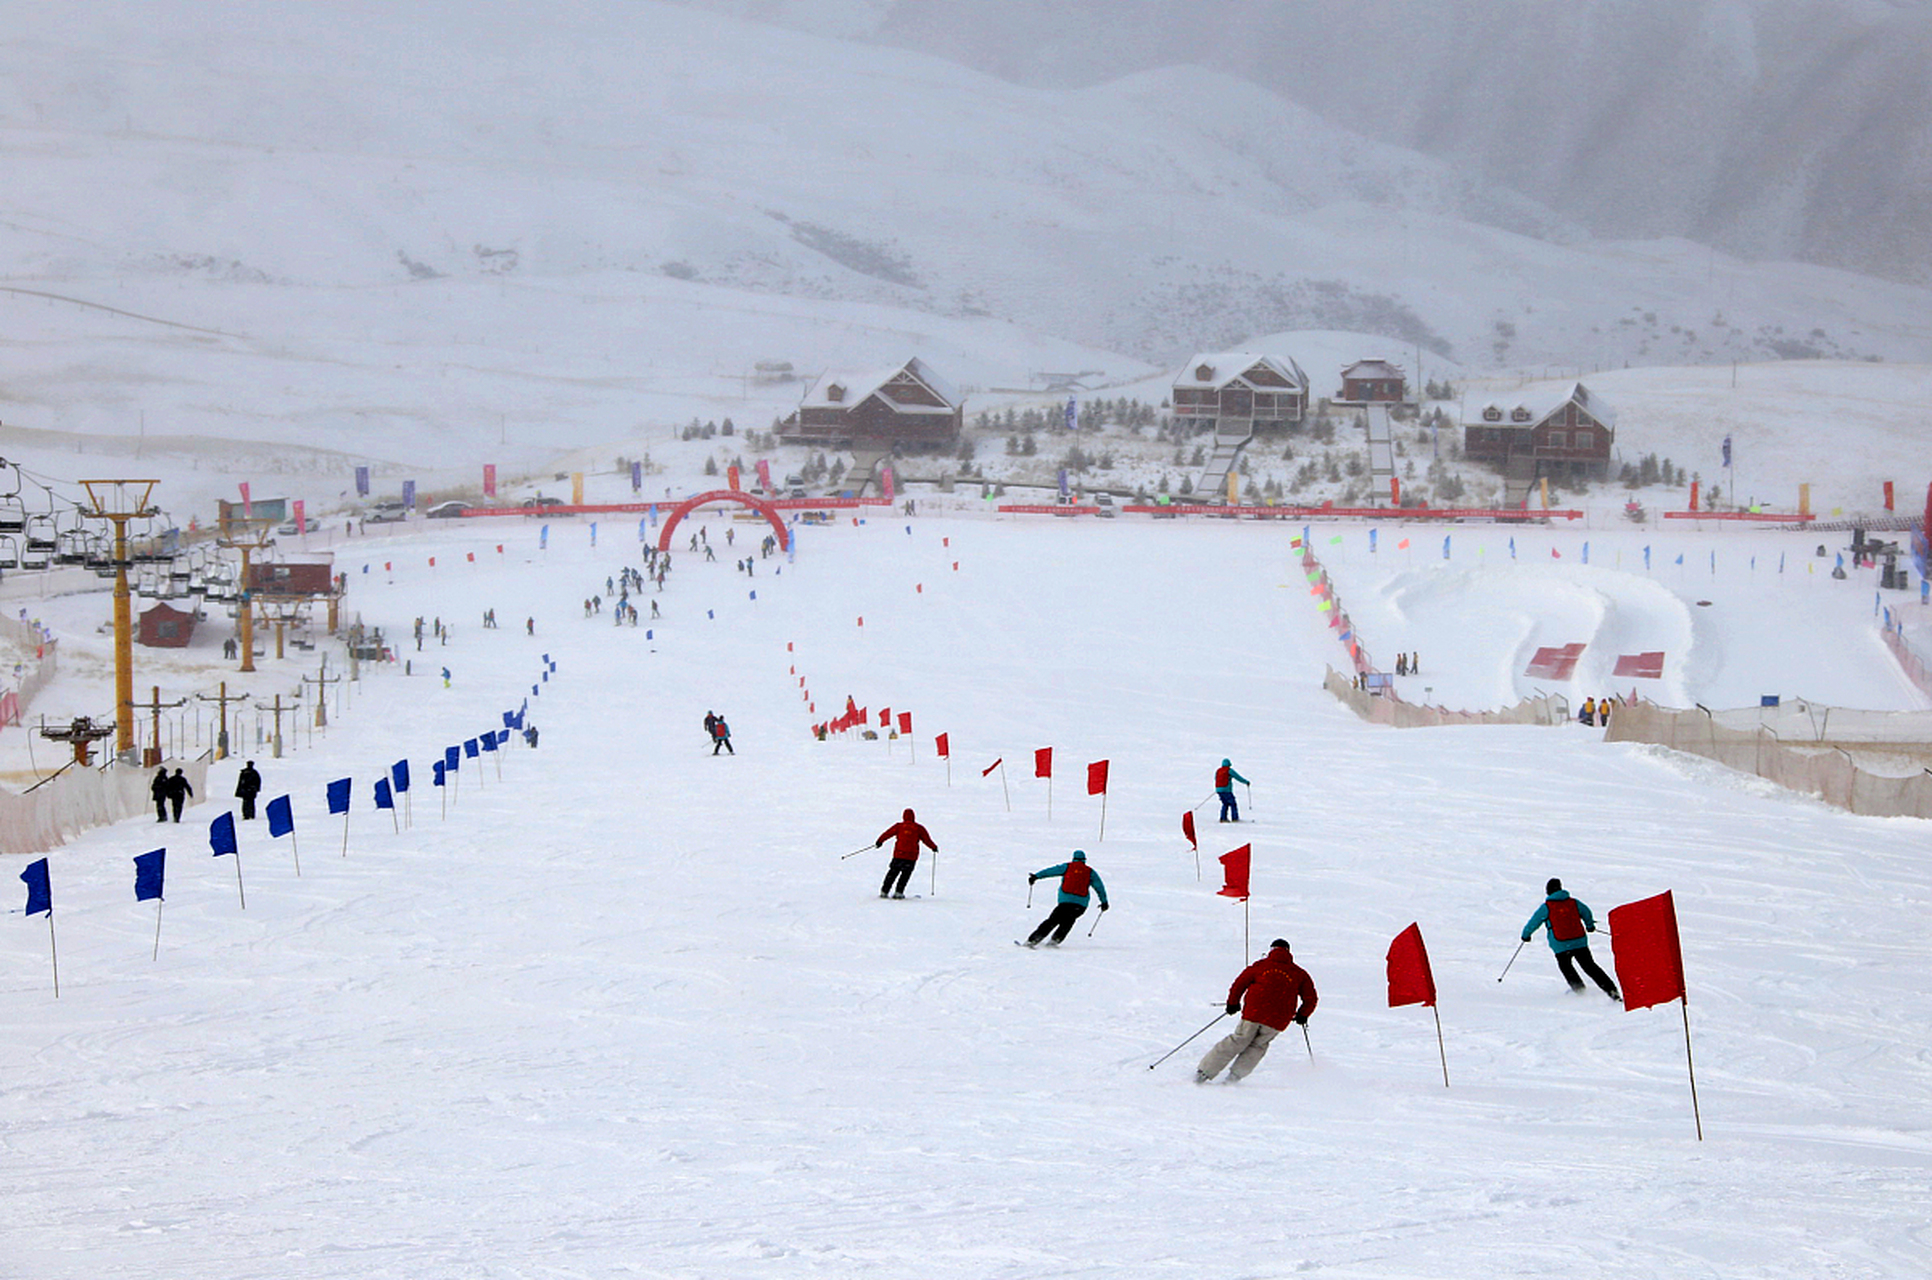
0 2 1932 525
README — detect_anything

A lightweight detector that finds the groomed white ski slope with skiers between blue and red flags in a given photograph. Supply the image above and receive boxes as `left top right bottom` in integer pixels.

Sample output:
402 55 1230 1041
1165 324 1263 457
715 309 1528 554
0 515 1932 1280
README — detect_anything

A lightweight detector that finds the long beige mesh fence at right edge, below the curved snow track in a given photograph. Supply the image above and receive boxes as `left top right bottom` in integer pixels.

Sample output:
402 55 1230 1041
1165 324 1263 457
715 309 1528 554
1605 701 1932 819
